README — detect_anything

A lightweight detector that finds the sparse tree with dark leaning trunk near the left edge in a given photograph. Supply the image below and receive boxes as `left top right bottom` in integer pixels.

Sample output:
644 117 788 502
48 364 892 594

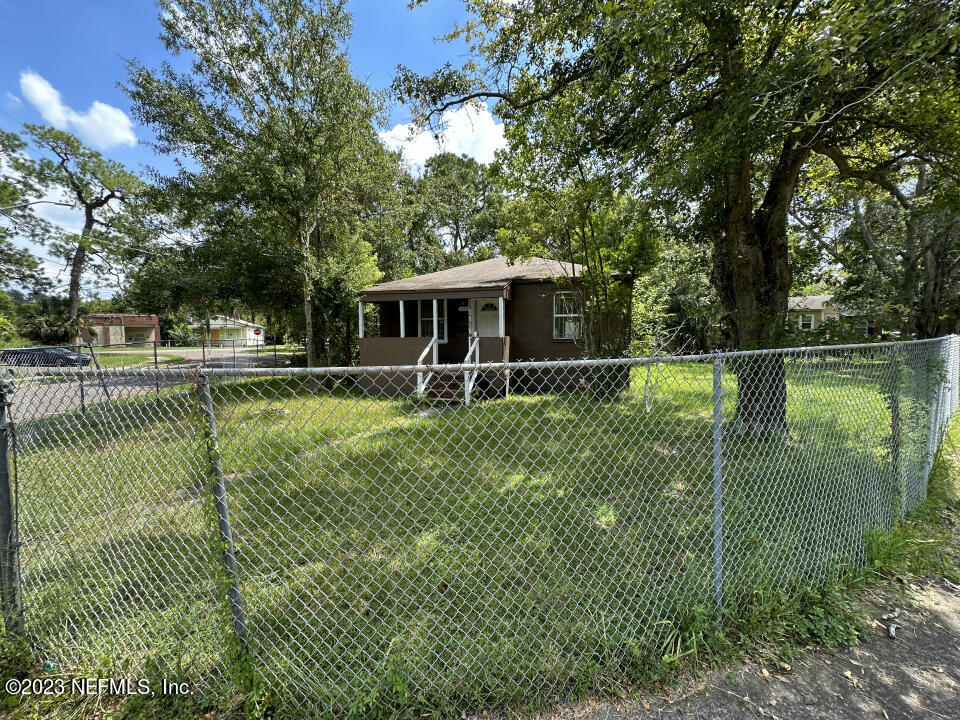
26 125 149 322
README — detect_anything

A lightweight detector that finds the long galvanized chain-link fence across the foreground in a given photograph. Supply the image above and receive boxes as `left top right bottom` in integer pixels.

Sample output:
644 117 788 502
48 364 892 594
0 336 960 717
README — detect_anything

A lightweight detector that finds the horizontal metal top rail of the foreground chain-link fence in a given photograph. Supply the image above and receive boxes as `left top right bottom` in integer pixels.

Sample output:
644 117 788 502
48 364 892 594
3 335 957 379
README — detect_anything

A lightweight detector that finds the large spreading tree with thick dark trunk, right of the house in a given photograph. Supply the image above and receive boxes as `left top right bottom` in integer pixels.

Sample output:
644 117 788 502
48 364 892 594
394 0 960 429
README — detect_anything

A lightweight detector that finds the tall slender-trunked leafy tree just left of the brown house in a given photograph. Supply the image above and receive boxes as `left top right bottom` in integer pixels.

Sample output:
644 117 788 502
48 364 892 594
126 0 390 366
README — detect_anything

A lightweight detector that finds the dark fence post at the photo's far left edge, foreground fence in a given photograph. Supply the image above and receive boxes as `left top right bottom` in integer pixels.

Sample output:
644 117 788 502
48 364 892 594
0 377 23 636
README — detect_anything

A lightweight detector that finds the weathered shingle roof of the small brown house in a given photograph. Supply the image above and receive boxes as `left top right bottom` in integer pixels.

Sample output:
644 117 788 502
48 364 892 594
363 257 583 299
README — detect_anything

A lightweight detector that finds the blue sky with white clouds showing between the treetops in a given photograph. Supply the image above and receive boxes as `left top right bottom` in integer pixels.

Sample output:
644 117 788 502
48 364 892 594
0 0 503 290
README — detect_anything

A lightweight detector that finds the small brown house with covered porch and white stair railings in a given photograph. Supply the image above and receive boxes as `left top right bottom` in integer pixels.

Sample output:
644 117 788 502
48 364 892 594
359 257 582 392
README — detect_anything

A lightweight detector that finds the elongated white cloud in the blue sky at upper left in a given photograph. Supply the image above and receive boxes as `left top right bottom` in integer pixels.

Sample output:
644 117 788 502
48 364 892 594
20 70 137 150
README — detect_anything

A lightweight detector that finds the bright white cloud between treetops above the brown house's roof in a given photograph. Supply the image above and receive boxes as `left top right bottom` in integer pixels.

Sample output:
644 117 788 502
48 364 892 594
380 105 507 173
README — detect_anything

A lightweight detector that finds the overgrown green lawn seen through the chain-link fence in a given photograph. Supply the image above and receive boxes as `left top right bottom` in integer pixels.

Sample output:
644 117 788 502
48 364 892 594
1 363 953 716
